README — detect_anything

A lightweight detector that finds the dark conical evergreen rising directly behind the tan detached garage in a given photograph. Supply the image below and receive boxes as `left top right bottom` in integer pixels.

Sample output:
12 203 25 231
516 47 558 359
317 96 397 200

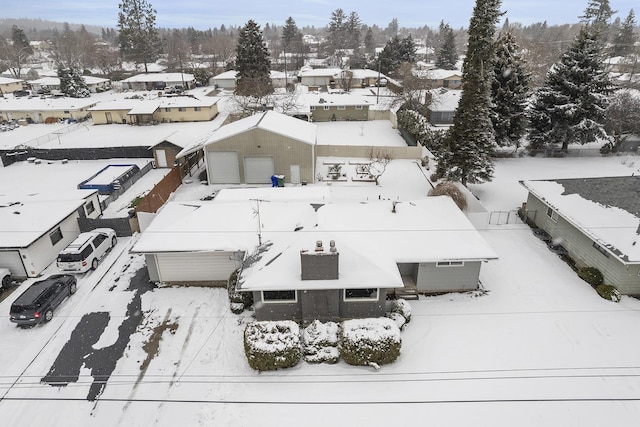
235 20 273 98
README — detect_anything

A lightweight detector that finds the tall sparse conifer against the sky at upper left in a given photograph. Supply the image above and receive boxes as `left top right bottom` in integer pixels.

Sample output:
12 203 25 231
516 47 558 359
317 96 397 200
118 0 161 73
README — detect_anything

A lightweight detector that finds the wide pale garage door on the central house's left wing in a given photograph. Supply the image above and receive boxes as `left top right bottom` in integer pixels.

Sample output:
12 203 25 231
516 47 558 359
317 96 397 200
156 252 240 282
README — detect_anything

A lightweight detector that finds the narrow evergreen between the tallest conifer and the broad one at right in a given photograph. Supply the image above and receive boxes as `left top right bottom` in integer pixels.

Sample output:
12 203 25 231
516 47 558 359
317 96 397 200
491 32 530 147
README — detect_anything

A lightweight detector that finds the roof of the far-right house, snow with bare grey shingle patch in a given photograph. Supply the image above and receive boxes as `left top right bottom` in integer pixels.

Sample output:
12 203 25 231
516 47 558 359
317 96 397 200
522 176 640 263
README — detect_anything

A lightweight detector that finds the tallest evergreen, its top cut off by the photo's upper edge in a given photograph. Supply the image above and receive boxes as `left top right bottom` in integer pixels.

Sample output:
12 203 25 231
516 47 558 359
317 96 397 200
437 0 501 185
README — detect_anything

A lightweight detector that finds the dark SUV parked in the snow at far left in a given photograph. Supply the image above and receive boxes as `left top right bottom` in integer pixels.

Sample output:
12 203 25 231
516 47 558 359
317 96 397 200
9 274 76 326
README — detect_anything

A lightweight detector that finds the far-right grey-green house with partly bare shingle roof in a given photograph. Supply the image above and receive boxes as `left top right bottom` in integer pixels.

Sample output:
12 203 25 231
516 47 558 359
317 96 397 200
521 176 640 295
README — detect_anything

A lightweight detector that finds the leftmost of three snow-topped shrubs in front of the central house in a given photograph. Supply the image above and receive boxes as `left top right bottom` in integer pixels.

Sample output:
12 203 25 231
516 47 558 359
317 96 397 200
244 320 302 371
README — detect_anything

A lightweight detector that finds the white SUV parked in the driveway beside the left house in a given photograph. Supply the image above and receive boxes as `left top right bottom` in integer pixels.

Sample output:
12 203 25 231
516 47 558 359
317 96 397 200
56 228 117 273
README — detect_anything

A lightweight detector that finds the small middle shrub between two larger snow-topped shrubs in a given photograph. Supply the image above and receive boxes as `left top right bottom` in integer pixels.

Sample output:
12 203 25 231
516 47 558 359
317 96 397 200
302 320 340 364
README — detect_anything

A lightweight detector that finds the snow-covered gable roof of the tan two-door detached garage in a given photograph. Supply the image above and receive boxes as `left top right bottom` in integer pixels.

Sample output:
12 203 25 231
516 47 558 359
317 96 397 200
178 111 316 157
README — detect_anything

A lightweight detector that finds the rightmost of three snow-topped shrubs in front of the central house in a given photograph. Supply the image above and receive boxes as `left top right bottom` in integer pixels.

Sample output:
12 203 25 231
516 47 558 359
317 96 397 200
340 318 402 366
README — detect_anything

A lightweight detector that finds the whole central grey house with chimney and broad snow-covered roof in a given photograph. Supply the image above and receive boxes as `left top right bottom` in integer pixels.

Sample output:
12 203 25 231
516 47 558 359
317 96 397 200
132 194 497 321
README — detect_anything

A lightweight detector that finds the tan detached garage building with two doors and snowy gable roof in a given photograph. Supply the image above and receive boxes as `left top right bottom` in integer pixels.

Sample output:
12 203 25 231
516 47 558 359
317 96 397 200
178 111 316 184
